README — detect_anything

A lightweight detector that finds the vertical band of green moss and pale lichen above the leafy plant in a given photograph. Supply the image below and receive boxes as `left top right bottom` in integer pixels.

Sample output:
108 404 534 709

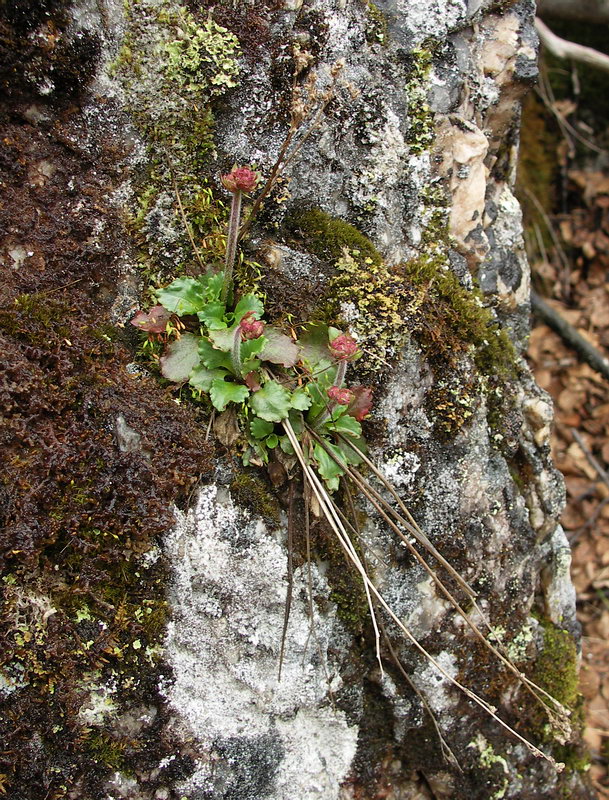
111 0 241 285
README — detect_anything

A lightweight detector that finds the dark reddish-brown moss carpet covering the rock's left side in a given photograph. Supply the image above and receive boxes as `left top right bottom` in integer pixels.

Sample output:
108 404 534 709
0 2 212 800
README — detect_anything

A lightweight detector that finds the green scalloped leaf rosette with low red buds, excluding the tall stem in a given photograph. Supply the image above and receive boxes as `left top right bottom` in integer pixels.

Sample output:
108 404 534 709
132 272 372 491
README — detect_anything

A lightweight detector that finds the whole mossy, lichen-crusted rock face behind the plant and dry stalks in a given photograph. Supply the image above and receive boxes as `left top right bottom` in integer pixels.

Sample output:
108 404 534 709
0 0 591 800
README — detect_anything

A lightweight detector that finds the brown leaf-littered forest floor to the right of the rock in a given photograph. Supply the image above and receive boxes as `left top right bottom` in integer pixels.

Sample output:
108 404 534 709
528 161 609 799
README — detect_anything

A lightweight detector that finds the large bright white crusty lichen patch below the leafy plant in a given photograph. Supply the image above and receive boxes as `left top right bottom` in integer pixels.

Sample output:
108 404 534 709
161 486 357 800
